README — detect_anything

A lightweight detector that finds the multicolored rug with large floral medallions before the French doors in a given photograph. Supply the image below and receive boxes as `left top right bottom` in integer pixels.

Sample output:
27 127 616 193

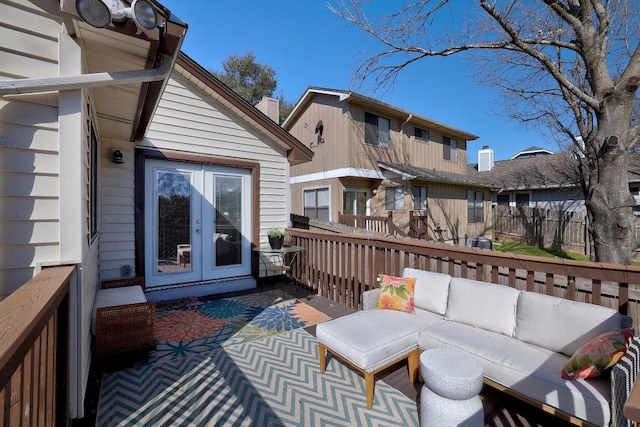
150 290 329 362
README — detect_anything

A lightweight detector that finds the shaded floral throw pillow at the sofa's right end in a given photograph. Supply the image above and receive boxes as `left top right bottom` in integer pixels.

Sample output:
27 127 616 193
562 329 633 380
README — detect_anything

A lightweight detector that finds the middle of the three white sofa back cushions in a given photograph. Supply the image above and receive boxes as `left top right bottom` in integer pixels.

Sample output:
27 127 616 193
445 277 520 336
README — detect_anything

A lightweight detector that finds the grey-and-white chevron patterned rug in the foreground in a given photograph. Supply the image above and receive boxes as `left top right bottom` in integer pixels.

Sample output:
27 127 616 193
96 329 418 426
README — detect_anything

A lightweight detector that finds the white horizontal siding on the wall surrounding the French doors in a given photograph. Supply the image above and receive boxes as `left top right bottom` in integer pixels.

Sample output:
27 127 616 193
100 72 289 278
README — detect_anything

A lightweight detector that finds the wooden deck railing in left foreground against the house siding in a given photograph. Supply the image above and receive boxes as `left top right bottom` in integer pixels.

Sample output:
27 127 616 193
0 266 75 426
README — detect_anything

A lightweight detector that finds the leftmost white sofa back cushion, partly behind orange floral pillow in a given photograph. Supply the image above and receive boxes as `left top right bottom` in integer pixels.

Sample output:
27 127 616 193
402 268 451 316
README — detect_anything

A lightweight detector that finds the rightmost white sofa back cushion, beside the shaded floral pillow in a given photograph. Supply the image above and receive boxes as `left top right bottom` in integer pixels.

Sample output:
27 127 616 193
515 291 620 356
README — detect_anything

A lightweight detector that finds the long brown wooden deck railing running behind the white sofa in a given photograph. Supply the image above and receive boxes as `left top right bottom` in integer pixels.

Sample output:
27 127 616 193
287 229 640 330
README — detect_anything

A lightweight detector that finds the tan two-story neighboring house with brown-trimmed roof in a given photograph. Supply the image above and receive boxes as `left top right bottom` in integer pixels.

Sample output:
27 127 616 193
282 87 492 243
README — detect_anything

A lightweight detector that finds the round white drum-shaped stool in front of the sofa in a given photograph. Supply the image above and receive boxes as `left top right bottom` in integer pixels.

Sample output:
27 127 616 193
420 348 484 427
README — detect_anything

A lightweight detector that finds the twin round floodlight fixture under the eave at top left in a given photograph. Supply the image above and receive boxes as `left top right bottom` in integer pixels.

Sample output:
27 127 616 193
76 0 158 30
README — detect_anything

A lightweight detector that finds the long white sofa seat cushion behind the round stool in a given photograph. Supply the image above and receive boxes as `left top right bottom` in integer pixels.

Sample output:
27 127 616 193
418 320 611 425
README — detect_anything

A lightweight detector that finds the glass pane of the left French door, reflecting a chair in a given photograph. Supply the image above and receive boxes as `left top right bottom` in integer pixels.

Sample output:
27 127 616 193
155 171 191 273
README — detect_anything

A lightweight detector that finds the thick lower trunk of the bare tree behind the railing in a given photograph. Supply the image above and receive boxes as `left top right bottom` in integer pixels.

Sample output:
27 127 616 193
586 126 634 264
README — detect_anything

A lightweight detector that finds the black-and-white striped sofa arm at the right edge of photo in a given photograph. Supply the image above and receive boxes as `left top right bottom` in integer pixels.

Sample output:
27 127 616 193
611 337 640 427
